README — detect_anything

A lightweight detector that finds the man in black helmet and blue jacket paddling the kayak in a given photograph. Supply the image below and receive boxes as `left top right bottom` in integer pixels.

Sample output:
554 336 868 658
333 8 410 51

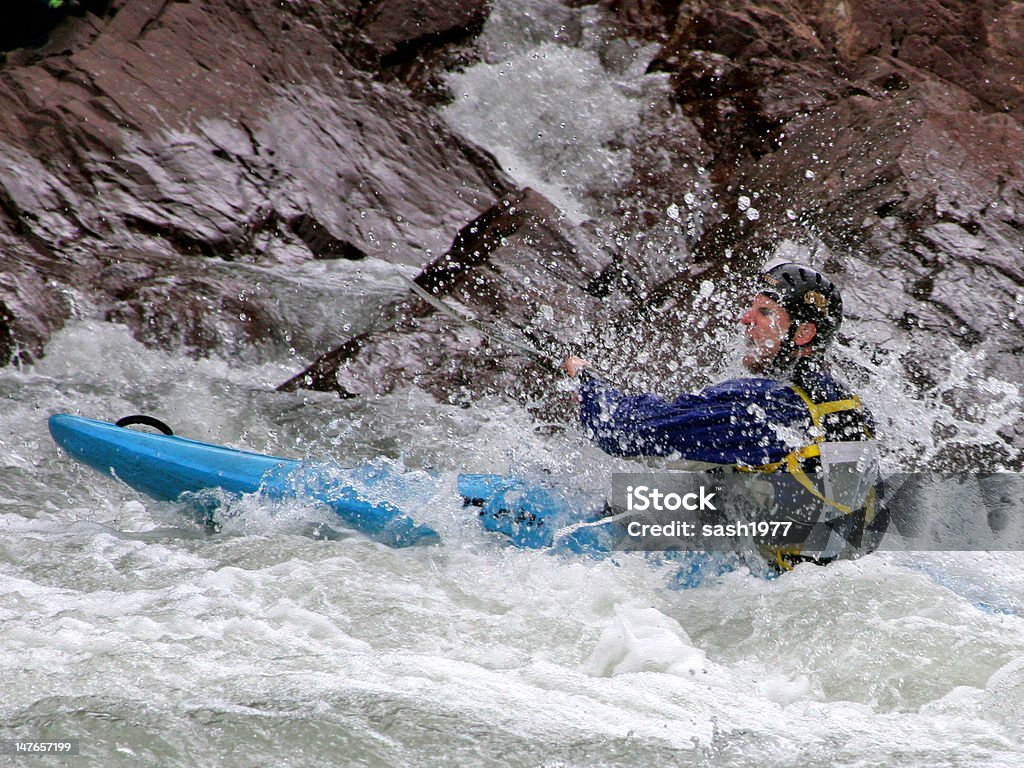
563 263 884 568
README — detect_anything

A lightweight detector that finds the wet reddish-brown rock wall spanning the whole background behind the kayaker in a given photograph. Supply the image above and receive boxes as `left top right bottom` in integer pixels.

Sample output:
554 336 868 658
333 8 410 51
0 0 1024 466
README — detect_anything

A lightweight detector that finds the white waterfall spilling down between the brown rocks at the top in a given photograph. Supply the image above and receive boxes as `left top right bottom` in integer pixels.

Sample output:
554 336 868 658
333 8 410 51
442 2 664 221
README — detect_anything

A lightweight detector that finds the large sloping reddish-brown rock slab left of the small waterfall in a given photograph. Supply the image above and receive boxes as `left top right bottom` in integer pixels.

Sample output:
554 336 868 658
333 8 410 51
0 0 511 361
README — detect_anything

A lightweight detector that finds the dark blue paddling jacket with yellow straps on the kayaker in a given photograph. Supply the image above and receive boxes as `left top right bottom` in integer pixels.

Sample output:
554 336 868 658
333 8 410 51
580 358 885 568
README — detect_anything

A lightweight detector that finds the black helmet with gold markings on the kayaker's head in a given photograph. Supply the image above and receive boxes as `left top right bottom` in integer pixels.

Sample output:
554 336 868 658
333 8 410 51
759 263 843 346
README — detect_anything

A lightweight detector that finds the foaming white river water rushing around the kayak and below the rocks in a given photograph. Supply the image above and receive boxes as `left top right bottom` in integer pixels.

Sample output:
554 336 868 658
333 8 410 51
0 1 1024 768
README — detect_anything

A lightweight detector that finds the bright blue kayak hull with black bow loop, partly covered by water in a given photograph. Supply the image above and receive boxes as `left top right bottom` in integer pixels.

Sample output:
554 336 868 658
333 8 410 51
49 414 613 553
